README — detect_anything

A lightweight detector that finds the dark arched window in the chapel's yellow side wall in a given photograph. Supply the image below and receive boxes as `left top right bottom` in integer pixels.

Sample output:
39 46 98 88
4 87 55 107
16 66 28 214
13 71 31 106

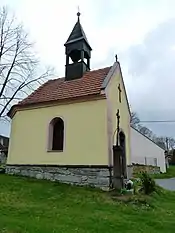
49 117 64 151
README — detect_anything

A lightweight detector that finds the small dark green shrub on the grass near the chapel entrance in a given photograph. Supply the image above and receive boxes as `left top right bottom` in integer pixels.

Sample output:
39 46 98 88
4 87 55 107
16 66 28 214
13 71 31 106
140 172 156 195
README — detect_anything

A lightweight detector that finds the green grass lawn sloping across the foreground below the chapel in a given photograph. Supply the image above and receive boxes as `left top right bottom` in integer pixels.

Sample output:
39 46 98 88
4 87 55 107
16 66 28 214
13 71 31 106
0 174 175 233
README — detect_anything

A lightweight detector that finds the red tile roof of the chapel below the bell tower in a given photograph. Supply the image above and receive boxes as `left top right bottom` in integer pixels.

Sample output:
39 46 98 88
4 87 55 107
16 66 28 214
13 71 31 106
18 67 111 106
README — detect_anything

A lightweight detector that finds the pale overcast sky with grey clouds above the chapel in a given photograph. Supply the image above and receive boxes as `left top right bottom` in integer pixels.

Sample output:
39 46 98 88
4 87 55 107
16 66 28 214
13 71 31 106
0 0 175 137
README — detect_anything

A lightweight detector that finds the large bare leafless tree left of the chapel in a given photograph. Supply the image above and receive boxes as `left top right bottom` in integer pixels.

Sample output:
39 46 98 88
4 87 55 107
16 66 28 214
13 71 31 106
0 7 51 119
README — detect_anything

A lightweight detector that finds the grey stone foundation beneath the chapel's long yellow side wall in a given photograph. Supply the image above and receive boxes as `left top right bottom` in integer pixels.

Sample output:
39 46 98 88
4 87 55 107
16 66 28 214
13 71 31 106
6 165 110 190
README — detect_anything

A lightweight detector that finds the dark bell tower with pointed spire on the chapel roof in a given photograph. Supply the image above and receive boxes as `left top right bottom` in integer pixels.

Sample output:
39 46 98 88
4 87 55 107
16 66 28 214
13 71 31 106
64 12 92 81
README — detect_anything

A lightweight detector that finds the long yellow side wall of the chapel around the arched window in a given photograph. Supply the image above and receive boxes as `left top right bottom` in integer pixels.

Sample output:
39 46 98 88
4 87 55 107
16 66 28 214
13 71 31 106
7 99 108 165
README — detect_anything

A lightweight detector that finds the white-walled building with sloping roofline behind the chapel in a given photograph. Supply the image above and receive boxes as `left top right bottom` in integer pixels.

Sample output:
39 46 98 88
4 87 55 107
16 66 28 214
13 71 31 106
131 127 166 172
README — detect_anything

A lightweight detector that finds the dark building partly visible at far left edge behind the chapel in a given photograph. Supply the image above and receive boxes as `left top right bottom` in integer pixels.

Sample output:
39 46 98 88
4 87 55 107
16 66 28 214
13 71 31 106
0 135 9 163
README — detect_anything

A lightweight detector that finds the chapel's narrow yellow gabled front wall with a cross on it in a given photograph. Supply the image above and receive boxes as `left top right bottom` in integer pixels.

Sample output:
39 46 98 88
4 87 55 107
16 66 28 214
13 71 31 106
106 68 130 164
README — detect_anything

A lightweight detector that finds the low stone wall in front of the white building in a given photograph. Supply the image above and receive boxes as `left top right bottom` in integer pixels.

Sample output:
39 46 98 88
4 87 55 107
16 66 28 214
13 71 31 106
128 164 160 178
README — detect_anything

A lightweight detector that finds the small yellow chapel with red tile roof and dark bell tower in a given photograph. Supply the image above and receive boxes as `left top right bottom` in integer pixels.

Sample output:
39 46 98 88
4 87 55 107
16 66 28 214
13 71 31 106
7 14 130 189
